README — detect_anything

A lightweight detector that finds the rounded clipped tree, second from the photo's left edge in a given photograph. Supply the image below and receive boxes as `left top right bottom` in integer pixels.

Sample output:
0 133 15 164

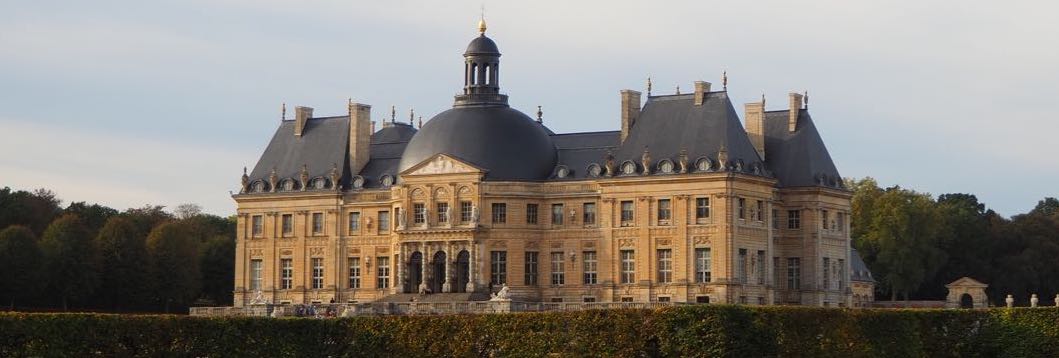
40 214 98 310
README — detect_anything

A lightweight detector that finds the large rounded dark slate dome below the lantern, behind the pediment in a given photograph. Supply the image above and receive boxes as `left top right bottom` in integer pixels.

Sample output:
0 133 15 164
399 106 557 180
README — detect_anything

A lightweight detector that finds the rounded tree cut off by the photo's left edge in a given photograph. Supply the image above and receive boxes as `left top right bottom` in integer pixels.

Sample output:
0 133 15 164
0 226 40 309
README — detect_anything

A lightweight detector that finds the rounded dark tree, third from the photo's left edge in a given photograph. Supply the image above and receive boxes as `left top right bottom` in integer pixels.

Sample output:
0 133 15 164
95 216 151 309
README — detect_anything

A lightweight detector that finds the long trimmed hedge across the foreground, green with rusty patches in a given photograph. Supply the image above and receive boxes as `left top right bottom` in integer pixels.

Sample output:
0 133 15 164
0 305 1059 357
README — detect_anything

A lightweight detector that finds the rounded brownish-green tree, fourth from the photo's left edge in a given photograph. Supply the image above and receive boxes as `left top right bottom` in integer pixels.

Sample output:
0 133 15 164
147 221 201 312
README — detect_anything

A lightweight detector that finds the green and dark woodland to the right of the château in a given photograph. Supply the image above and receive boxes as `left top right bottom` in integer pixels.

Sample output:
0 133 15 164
846 178 1059 306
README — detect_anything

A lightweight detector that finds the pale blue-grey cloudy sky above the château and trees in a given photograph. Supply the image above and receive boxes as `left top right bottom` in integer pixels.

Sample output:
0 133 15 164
0 0 1059 216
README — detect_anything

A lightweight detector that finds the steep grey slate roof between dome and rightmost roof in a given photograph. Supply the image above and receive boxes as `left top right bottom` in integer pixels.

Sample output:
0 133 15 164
614 92 761 171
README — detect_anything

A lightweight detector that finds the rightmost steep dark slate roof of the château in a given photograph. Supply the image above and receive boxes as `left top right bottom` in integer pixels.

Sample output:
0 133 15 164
765 109 843 187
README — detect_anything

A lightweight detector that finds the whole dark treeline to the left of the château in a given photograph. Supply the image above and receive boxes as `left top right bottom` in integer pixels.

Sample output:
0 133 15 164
0 187 235 311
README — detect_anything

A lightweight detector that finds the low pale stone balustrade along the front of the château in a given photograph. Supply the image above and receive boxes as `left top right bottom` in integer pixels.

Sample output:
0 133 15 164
190 301 689 318
